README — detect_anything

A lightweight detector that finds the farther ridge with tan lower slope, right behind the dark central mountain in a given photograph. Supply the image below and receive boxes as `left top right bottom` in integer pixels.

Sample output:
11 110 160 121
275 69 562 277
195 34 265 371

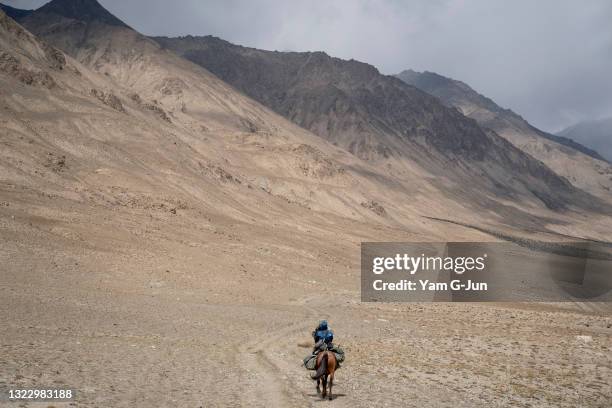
397 70 612 200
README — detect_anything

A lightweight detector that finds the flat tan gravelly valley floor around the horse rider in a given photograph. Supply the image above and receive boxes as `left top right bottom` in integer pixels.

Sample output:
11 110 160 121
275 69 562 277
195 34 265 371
0 197 612 407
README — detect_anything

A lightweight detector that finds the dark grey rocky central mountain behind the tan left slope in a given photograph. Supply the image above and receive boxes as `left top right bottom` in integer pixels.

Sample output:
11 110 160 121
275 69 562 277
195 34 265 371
149 36 608 214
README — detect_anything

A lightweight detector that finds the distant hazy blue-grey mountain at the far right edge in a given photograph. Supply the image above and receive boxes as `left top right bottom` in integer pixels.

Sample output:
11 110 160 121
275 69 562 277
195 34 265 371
557 118 612 162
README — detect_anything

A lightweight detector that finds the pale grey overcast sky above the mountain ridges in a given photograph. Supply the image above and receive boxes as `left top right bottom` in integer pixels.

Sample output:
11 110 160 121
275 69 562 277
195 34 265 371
5 0 612 131
